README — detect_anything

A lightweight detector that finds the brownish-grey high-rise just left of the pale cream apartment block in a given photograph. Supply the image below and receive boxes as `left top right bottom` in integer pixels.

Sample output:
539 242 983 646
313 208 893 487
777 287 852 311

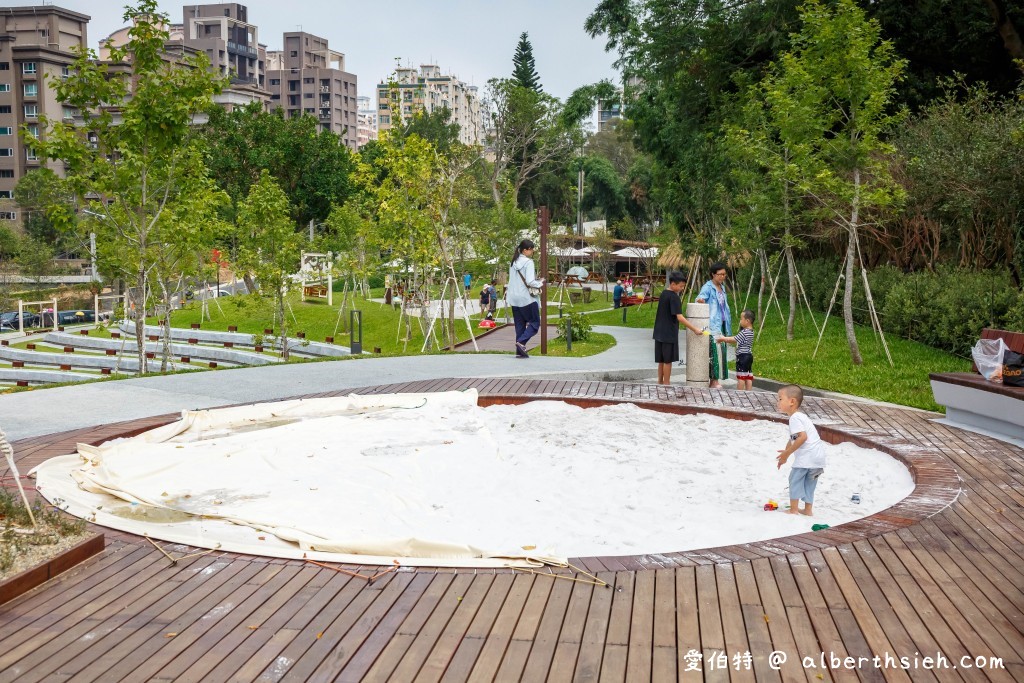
266 32 358 150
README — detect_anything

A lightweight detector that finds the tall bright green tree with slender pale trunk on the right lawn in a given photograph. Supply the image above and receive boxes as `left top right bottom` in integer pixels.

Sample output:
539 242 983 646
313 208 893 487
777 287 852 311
762 0 904 365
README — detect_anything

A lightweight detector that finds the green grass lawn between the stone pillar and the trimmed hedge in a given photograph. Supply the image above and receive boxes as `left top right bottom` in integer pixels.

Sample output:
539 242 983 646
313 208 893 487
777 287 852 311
591 305 971 412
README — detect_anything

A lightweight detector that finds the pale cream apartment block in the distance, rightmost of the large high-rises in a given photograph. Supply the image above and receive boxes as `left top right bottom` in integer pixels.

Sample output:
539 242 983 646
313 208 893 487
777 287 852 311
377 65 483 144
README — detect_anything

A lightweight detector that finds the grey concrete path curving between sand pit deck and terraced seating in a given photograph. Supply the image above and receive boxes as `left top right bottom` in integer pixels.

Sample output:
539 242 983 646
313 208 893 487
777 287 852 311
0 327 685 440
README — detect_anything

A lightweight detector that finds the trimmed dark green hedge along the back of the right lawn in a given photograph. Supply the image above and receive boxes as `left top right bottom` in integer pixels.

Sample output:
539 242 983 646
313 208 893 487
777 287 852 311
736 259 1024 356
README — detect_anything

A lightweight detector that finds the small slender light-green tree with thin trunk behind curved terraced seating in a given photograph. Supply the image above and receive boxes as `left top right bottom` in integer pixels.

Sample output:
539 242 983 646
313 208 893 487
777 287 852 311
238 169 302 360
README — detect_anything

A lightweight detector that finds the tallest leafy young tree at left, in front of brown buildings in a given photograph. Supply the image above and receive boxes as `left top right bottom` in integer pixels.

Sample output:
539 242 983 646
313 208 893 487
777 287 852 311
35 0 230 373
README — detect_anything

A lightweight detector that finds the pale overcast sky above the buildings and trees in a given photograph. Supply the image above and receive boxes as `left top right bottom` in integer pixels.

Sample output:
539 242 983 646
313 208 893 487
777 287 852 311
12 0 618 99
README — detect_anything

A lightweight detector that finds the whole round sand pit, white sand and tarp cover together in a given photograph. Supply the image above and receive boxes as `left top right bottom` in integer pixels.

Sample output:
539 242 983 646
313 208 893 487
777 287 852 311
29 391 913 566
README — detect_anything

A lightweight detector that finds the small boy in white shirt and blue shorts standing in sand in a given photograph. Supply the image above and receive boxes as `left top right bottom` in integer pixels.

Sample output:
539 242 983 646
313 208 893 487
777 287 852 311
777 384 825 517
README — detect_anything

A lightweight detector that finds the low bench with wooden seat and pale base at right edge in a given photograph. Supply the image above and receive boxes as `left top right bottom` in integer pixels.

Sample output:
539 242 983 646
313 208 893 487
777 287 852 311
929 329 1024 441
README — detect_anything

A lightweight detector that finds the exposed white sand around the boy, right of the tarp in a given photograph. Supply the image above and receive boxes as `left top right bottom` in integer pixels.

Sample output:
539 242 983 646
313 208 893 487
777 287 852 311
484 401 913 557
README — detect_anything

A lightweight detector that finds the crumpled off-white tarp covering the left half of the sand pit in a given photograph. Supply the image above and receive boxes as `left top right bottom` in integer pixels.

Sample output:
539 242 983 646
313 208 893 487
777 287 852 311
35 390 557 565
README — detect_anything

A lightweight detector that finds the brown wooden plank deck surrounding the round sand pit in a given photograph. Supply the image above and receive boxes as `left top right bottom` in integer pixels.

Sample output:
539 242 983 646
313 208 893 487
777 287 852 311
0 379 1024 683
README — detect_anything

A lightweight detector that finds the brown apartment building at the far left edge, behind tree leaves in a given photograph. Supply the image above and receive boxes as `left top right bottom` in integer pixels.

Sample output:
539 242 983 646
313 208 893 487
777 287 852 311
0 5 89 216
